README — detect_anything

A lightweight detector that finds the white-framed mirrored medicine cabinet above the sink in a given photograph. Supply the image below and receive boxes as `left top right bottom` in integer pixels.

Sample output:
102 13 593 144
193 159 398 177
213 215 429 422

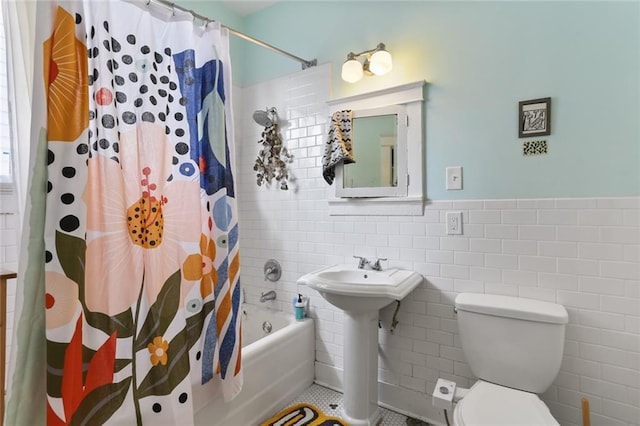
328 81 424 215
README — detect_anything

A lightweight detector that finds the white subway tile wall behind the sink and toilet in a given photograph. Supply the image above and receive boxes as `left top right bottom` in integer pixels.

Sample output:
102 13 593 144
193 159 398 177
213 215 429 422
235 65 640 426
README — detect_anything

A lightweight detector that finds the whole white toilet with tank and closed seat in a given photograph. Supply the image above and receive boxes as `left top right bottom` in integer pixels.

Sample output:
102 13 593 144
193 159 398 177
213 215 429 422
453 293 568 426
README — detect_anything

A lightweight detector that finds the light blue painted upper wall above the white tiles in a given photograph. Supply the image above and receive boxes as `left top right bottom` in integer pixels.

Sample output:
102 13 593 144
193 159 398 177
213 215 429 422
188 1 640 199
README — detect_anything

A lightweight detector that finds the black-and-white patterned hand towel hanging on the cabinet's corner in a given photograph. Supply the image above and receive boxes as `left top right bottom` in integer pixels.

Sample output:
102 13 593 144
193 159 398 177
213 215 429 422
322 110 356 185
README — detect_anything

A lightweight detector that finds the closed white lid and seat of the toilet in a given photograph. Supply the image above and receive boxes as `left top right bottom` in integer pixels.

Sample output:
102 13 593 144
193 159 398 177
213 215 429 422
453 380 559 426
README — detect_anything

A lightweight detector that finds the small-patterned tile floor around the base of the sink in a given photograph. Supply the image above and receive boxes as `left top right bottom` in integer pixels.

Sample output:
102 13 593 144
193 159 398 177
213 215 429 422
283 384 427 426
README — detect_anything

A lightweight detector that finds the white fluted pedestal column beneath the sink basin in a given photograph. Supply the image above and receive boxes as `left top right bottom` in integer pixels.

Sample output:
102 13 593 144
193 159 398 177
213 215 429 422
343 310 380 426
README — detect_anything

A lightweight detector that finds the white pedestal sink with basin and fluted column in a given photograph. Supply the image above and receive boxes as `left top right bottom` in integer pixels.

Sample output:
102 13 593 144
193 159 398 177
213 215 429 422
298 265 422 426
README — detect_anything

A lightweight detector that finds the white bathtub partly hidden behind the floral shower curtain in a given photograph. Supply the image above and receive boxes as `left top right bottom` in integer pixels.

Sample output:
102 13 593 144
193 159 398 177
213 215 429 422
194 304 315 426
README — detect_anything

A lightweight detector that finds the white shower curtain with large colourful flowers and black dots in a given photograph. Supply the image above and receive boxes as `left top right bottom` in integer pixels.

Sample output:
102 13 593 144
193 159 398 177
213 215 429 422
7 0 242 425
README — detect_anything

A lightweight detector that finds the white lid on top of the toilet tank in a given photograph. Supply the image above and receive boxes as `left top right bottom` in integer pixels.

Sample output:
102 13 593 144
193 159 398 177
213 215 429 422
455 293 569 324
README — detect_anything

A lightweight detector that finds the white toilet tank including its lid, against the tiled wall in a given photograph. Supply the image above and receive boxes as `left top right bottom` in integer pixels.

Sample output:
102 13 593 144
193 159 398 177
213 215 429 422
455 293 568 393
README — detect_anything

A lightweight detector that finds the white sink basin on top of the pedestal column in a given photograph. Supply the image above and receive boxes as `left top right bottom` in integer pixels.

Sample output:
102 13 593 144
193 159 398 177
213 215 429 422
298 265 422 312
